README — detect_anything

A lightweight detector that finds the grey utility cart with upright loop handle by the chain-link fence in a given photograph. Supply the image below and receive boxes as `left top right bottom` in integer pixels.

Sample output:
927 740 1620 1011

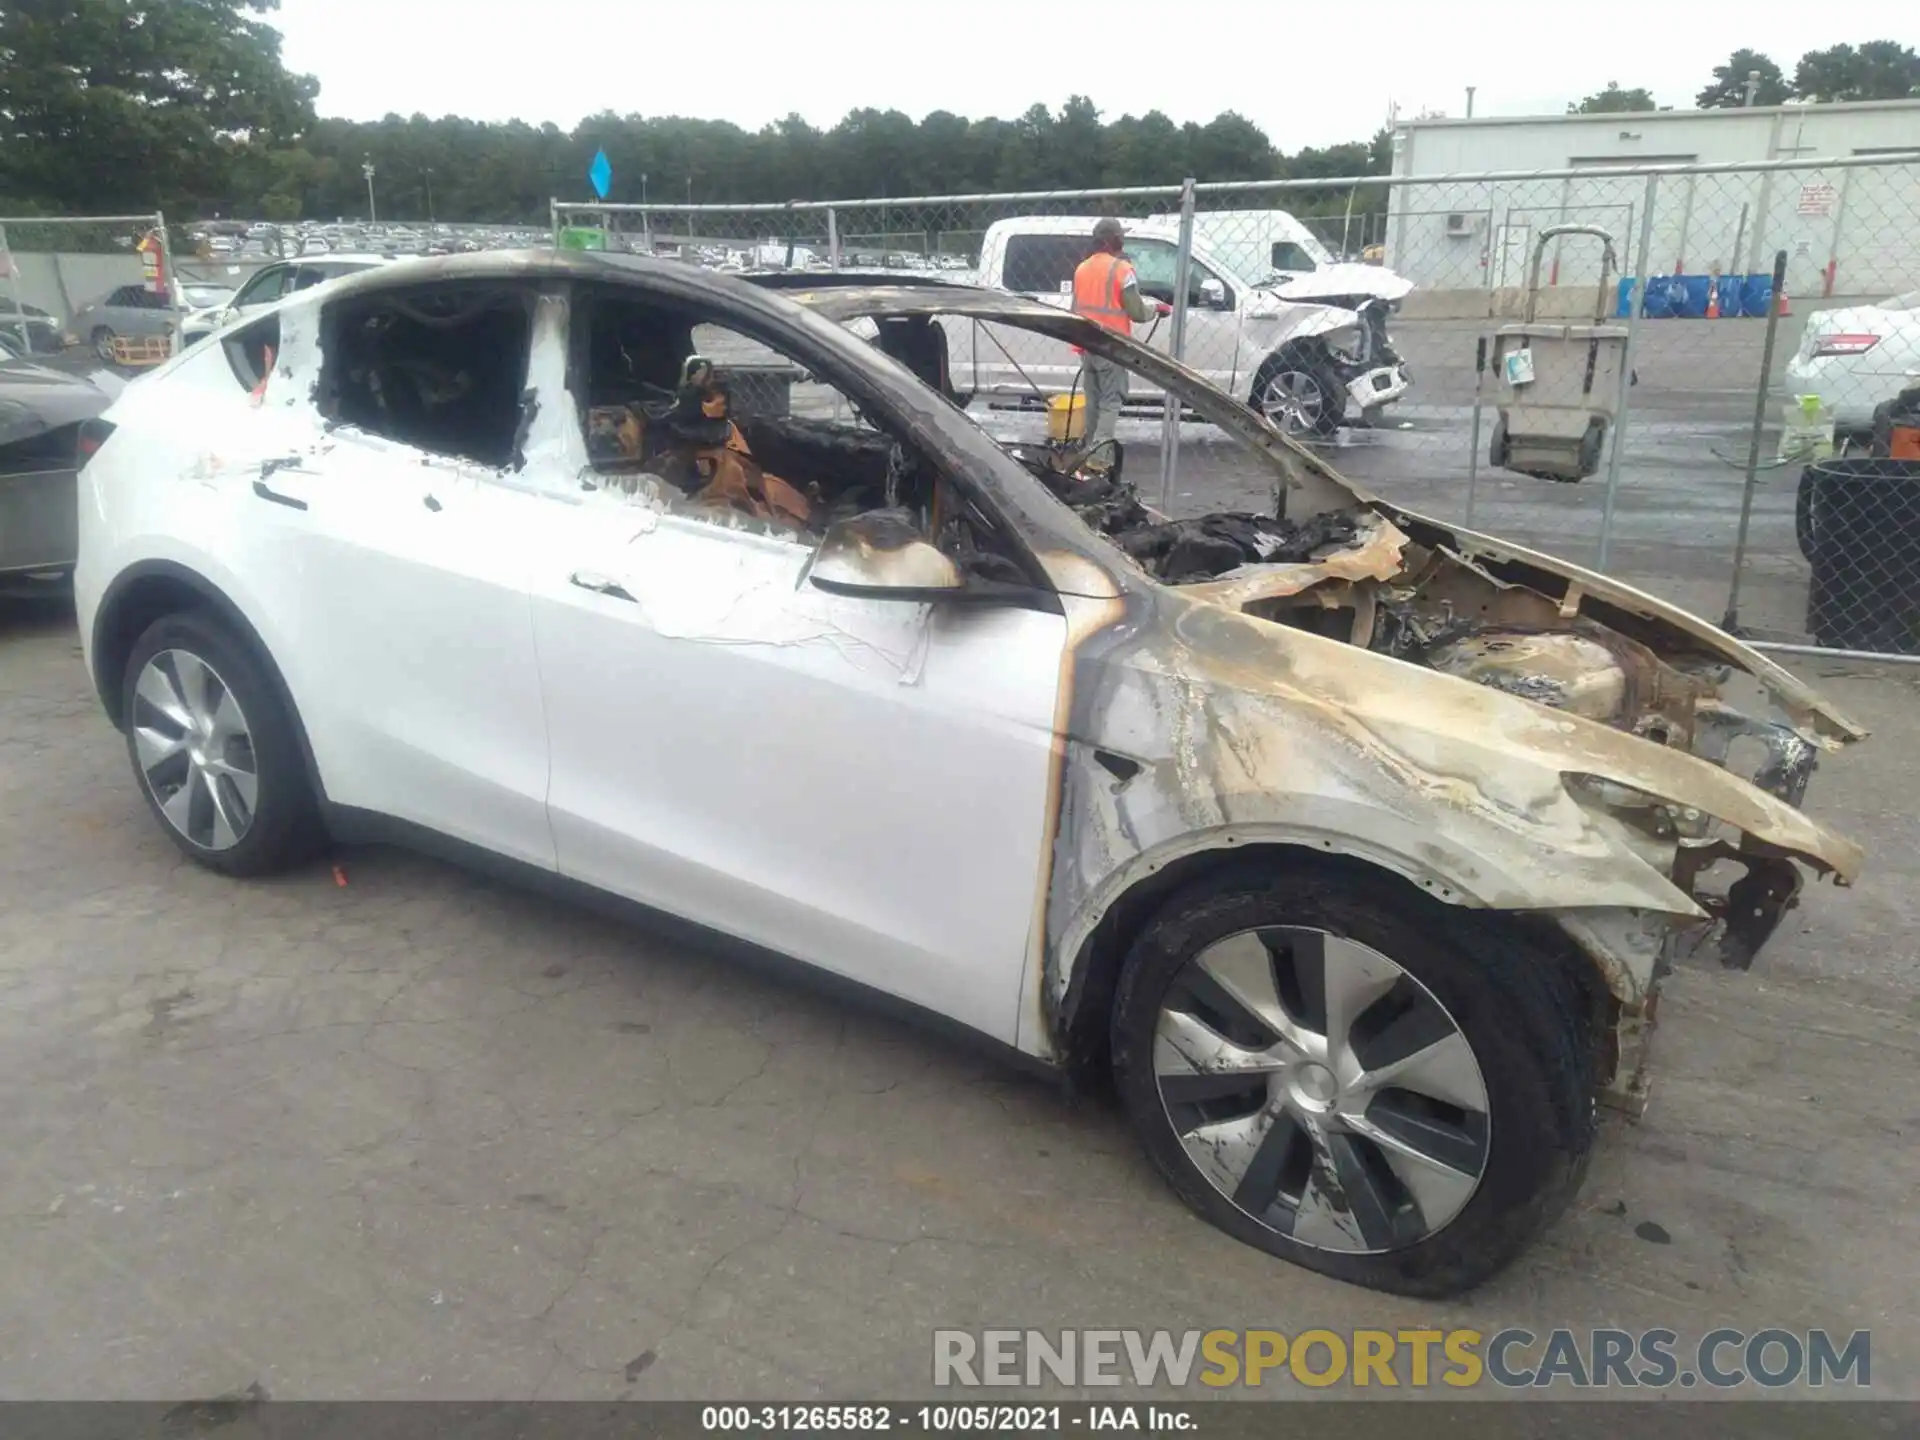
1488 225 1626 480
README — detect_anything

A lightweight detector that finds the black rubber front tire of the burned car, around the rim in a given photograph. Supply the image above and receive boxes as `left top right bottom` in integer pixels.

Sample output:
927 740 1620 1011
1112 862 1603 1298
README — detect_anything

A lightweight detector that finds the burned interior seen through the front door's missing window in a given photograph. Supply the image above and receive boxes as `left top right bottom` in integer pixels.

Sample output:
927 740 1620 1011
568 286 1029 584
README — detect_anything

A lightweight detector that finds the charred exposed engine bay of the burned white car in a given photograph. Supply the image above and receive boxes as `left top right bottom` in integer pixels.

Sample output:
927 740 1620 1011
1008 445 1834 968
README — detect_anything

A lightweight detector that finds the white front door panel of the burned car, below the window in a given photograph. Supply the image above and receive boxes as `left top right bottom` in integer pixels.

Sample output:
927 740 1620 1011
532 295 1066 1041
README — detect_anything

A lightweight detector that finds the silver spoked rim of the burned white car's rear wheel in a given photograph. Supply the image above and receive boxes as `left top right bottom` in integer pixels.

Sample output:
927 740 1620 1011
132 649 259 851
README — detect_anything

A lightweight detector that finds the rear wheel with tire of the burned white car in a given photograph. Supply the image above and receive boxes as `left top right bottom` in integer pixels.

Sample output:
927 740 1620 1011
123 612 321 876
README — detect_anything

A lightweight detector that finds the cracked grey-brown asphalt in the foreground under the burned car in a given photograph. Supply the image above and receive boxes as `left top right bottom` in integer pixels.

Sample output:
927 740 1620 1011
0 576 1920 1400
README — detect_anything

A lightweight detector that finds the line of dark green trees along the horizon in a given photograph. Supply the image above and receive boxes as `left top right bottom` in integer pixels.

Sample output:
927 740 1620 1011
0 0 1920 223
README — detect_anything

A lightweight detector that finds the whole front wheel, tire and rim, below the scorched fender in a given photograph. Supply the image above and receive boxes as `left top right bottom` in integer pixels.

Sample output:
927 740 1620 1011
1114 864 1599 1296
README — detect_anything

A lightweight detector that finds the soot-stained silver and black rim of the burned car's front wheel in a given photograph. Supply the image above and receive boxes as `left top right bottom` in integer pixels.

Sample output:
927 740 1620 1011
1154 925 1490 1254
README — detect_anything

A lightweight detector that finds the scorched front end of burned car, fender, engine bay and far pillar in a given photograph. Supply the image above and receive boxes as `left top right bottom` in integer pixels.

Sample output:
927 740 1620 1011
775 282 1864 1112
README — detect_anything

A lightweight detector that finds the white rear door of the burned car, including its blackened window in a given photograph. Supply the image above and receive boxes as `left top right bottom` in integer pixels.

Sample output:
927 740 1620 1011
240 284 566 870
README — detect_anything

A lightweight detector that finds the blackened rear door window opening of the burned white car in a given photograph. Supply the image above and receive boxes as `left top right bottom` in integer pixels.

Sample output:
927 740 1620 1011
321 284 534 467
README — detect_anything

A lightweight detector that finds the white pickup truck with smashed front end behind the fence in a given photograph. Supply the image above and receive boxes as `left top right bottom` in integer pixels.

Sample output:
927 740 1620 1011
943 215 1409 436
